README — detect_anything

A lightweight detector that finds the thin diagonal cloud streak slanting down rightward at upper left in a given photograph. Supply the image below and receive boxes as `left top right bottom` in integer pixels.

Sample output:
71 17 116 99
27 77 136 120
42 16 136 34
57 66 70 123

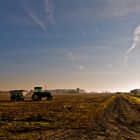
22 3 46 32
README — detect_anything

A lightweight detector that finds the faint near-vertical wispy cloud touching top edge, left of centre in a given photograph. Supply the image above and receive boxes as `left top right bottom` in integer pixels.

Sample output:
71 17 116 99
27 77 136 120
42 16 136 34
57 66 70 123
43 0 55 24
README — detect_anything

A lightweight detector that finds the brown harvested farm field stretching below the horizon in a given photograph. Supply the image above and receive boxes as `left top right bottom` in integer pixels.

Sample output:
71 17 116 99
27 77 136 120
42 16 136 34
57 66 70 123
0 94 140 140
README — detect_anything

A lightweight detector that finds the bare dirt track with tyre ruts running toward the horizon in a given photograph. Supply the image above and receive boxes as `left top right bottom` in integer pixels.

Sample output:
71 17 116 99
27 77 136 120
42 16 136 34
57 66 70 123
93 95 140 140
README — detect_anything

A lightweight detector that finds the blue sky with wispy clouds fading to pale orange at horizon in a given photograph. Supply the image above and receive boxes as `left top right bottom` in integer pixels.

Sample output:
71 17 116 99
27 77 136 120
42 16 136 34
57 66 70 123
0 0 140 92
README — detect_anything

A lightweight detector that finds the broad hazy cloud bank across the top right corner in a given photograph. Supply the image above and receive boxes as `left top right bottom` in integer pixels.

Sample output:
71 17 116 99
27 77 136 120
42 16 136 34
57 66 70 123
63 0 140 22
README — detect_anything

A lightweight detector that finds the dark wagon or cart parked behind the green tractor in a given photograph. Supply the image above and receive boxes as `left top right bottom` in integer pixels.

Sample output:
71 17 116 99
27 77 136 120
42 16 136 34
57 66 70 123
9 90 24 101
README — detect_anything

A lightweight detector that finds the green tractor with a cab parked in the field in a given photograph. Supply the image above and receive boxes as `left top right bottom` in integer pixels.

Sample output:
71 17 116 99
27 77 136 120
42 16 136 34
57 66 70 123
32 87 53 101
